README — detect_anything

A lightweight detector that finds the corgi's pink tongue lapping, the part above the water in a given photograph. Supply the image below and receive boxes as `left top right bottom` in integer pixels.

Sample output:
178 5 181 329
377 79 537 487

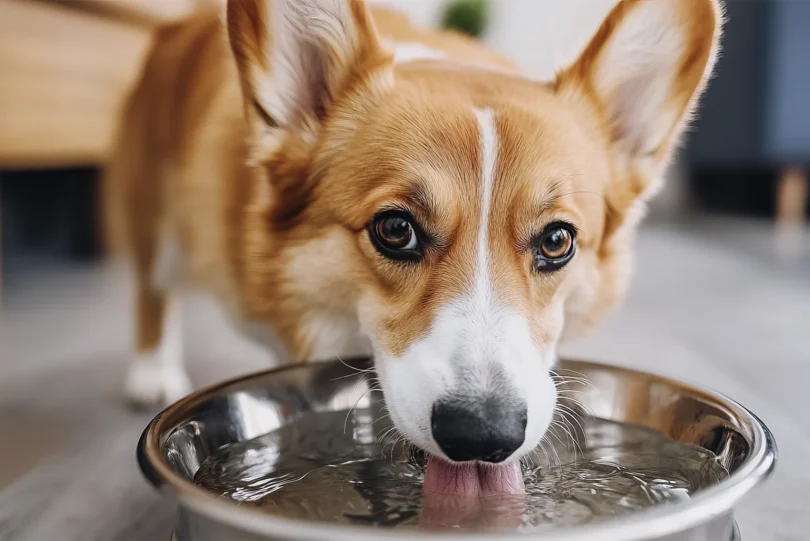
424 457 526 496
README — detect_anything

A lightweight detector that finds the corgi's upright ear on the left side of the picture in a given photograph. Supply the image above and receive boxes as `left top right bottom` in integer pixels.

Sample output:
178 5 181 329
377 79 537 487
227 0 388 151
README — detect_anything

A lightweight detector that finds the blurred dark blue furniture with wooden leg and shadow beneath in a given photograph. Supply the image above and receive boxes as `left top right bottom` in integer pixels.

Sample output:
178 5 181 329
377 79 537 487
685 0 810 220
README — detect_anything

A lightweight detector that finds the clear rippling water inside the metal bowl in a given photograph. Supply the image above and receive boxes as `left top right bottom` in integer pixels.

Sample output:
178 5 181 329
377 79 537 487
194 410 728 529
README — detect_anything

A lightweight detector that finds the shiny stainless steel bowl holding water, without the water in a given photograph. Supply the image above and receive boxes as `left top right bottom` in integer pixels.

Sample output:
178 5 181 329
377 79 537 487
138 359 776 541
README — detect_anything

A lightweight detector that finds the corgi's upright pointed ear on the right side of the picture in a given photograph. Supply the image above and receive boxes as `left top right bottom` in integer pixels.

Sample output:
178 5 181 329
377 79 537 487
557 0 722 179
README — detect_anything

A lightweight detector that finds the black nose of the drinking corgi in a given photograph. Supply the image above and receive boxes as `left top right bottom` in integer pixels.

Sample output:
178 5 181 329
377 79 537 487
431 398 526 462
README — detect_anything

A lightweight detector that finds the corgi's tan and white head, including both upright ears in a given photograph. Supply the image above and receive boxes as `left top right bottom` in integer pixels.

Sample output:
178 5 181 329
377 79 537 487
228 0 719 462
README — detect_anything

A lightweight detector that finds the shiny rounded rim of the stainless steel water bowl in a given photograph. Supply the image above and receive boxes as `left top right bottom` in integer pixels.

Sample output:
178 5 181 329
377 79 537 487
137 358 778 541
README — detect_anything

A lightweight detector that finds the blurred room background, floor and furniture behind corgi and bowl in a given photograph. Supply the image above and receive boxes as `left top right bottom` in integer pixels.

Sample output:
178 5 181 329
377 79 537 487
0 0 810 541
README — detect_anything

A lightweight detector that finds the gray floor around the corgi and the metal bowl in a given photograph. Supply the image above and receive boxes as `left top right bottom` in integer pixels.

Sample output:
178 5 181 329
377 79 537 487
0 216 810 541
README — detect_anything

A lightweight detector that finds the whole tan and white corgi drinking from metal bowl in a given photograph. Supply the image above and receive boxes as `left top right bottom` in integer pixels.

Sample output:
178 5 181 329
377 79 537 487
107 0 722 490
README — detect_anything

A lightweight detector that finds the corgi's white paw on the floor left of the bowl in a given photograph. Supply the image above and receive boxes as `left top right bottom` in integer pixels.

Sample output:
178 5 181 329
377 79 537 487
124 355 192 407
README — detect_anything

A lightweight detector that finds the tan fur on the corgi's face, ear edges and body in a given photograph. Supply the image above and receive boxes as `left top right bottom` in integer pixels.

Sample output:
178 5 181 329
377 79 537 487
108 0 719 388
